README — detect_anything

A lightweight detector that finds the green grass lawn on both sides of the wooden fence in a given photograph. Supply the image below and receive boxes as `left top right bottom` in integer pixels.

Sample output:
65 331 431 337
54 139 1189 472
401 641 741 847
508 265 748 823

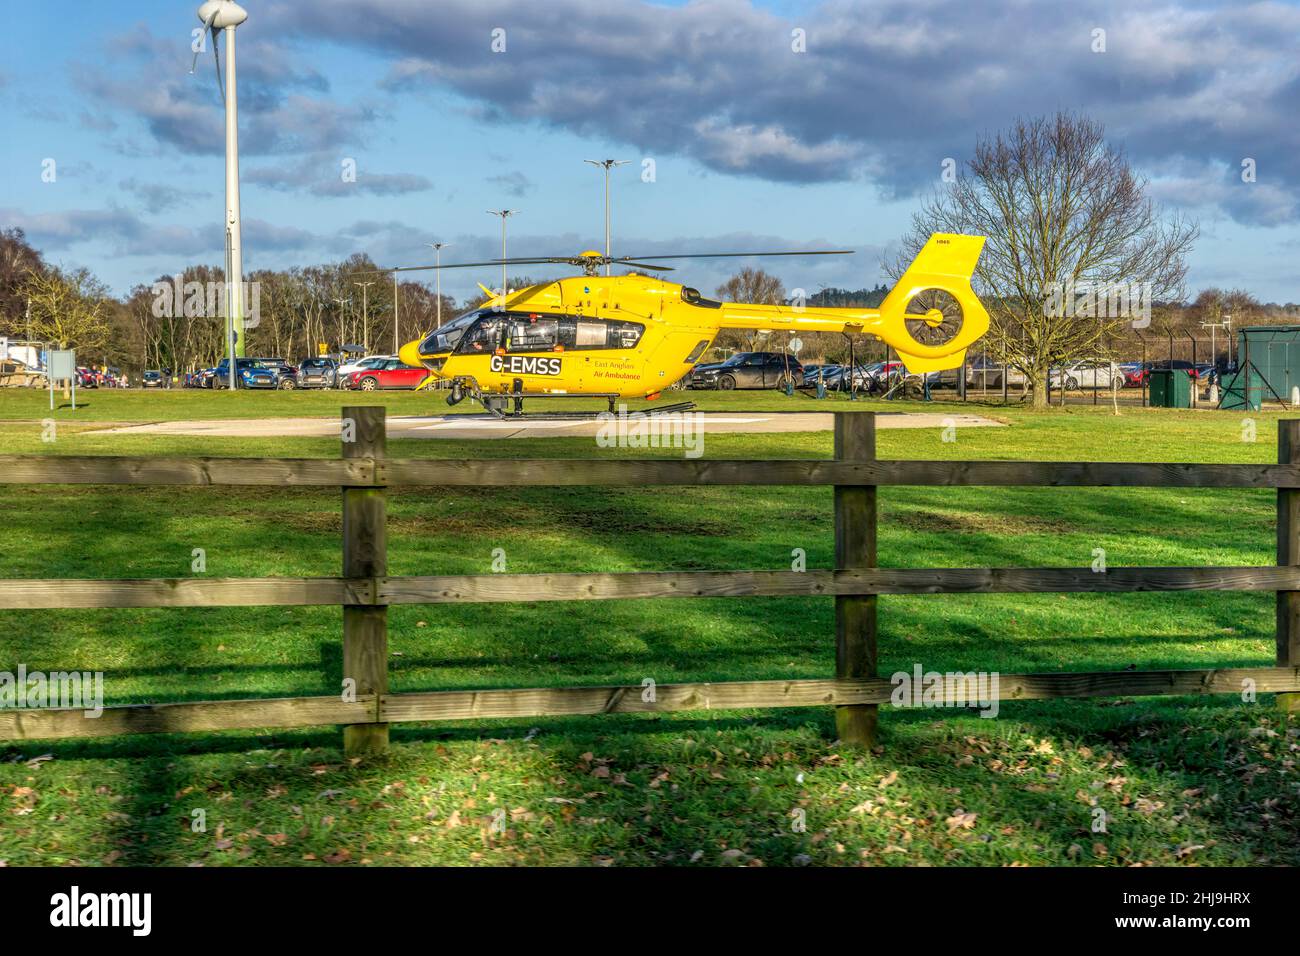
0 390 1300 865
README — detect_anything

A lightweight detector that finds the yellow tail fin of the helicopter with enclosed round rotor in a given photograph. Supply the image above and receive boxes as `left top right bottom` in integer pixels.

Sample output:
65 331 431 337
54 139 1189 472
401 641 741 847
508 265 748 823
880 233 988 372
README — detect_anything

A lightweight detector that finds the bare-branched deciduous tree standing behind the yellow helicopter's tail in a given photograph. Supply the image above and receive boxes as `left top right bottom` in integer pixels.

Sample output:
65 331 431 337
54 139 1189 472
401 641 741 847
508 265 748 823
885 113 1199 406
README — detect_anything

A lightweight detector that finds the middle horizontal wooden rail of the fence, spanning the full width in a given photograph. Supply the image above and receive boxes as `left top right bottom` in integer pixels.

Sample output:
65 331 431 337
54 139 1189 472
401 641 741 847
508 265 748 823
0 564 1300 610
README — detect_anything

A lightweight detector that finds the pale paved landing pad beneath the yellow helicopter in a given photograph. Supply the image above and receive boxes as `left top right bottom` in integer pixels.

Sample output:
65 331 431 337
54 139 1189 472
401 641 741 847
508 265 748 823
100 412 1002 438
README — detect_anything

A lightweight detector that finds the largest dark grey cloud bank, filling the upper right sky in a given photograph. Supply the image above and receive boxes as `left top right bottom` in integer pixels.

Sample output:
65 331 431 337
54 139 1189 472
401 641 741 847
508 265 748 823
260 0 1300 222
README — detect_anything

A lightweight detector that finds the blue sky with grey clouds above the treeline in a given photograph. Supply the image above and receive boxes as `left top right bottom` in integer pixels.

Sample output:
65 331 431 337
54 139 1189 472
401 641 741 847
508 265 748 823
0 0 1300 302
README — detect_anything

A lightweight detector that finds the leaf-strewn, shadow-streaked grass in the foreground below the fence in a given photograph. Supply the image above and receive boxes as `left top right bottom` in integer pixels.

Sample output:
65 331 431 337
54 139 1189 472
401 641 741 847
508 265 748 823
17 698 1300 865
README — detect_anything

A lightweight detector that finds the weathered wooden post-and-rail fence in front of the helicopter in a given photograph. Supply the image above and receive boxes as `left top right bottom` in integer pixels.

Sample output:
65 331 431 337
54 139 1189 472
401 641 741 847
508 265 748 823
0 406 1300 753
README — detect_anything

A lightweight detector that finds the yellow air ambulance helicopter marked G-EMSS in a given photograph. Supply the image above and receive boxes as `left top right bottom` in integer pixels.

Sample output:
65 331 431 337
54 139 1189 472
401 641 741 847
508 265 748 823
379 233 988 408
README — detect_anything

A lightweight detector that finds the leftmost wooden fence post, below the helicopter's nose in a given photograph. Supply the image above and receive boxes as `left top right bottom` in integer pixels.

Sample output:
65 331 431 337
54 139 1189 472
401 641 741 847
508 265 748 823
342 406 389 754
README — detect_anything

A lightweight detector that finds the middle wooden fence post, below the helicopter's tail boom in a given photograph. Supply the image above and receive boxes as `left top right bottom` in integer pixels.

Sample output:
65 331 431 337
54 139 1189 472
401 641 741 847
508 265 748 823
835 412 878 748
